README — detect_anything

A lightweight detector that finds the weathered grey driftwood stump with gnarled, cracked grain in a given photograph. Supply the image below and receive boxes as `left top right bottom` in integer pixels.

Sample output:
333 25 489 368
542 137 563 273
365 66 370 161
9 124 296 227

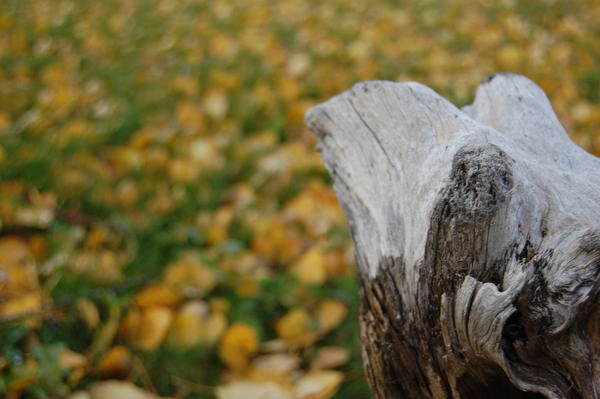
306 74 600 399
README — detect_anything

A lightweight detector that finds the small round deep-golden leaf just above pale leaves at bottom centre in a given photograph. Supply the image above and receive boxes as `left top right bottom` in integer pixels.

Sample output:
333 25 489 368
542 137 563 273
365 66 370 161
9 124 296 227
219 323 258 369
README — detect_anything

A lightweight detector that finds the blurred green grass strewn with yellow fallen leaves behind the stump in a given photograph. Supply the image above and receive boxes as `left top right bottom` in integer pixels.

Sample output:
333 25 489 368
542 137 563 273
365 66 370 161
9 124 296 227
0 0 600 399
